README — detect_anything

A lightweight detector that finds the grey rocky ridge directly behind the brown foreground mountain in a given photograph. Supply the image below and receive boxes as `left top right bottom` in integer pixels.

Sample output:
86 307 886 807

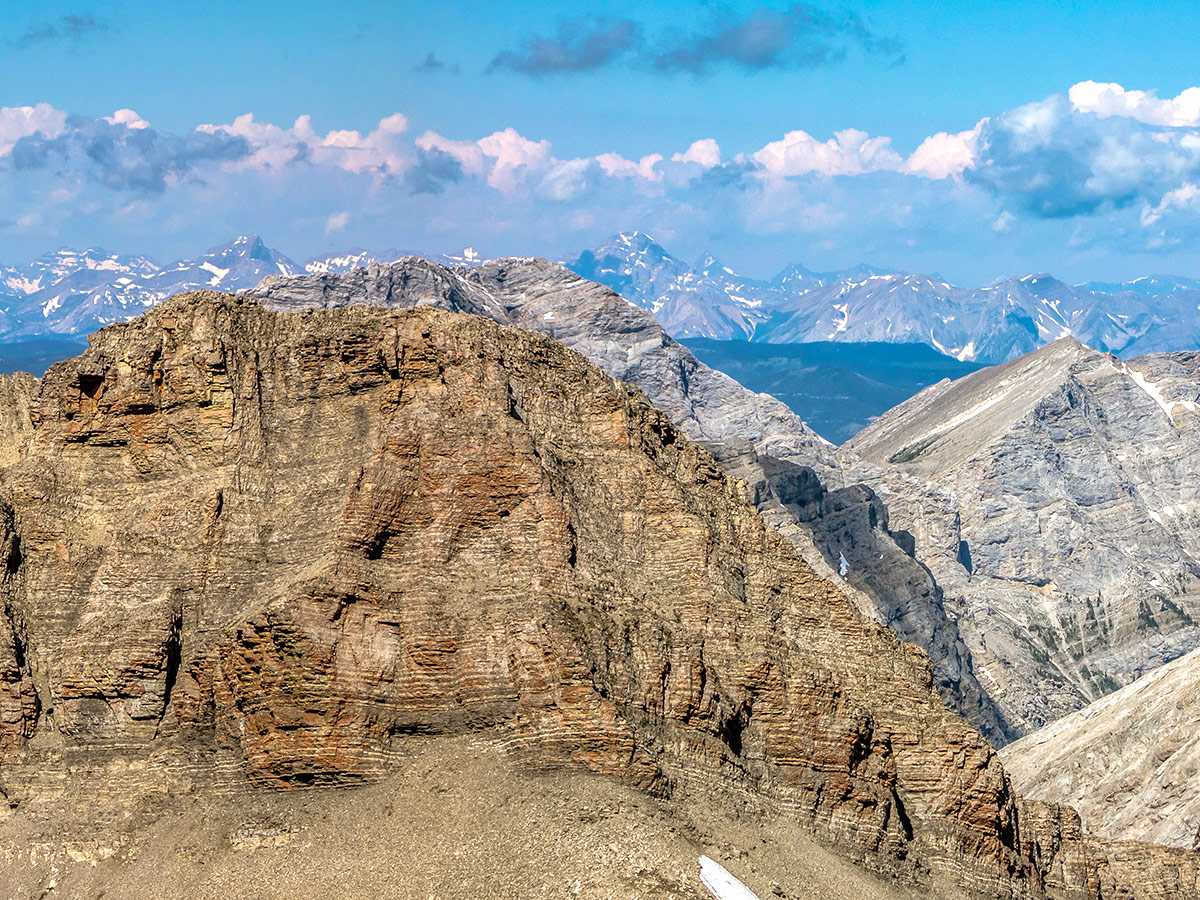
248 258 1015 743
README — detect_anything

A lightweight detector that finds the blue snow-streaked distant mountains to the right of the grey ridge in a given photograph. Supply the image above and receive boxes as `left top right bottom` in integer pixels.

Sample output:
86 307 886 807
564 232 1200 362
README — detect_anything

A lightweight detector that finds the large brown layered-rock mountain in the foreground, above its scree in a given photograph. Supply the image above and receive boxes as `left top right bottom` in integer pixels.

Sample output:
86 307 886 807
0 290 1200 898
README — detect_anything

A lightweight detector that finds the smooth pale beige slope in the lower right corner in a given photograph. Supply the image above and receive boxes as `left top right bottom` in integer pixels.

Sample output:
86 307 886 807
1001 650 1200 848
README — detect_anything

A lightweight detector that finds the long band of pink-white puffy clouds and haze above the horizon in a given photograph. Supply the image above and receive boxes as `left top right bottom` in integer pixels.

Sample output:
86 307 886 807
7 82 1200 283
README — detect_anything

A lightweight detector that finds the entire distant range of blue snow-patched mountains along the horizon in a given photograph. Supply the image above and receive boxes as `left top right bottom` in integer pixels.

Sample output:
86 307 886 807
7 232 1200 374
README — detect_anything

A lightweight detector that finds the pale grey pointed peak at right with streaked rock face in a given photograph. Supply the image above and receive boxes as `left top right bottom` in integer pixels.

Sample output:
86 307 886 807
848 338 1200 731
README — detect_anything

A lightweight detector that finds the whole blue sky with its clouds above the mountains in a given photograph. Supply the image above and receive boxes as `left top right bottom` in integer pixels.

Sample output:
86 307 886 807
0 0 1200 283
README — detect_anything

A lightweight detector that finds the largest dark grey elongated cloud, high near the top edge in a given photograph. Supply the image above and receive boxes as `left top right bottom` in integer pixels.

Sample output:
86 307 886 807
487 4 904 77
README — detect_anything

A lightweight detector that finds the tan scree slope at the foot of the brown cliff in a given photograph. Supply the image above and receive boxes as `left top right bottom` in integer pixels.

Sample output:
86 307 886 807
0 737 932 900
